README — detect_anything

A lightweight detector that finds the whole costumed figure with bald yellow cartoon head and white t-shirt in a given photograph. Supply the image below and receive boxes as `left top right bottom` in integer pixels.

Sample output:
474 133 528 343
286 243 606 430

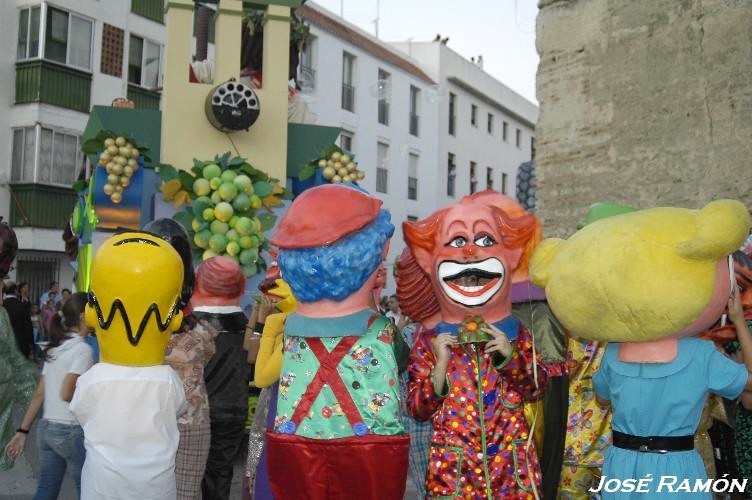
70 232 187 500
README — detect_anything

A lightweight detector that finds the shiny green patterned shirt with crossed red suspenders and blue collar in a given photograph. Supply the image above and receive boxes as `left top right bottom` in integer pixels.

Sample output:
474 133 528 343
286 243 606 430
274 310 407 439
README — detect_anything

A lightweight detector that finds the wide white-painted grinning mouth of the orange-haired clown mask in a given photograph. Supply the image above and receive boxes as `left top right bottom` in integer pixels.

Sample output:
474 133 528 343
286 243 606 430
438 257 505 307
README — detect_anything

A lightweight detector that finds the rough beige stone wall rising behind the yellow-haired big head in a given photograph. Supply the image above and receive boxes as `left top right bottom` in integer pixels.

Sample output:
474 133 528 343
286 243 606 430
536 0 752 236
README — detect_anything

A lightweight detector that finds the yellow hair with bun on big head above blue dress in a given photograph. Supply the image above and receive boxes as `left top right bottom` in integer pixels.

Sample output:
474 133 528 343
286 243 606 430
530 200 750 342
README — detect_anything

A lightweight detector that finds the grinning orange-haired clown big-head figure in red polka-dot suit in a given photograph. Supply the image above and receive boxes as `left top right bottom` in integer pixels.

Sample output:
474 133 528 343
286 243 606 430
396 192 547 498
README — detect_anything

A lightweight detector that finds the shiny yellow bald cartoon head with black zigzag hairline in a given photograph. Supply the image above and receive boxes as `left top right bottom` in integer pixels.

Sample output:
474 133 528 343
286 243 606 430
86 232 183 366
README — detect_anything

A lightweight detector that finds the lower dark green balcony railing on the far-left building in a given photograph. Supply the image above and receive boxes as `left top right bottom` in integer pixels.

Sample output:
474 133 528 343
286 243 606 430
10 184 76 229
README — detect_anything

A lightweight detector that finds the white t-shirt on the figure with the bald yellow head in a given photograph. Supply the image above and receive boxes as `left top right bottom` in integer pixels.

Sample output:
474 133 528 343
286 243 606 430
70 363 187 500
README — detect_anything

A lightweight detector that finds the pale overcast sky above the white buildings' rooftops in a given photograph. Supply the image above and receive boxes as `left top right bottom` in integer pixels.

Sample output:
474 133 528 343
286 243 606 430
313 0 538 103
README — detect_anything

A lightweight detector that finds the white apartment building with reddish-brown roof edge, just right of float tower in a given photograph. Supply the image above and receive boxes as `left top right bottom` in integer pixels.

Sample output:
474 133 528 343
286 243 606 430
296 2 443 291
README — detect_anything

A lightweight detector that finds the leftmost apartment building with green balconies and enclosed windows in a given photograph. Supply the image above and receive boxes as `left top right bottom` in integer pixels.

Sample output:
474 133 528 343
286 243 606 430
0 0 165 293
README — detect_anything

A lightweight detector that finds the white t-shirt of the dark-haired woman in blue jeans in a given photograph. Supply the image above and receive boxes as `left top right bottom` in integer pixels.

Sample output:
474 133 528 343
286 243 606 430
42 333 94 425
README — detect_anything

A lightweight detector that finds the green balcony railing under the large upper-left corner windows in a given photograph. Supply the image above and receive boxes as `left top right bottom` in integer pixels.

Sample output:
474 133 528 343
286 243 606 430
15 59 91 113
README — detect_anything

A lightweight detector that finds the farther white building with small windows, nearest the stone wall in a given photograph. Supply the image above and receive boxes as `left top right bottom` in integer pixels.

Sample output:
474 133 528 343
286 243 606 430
392 42 538 206
